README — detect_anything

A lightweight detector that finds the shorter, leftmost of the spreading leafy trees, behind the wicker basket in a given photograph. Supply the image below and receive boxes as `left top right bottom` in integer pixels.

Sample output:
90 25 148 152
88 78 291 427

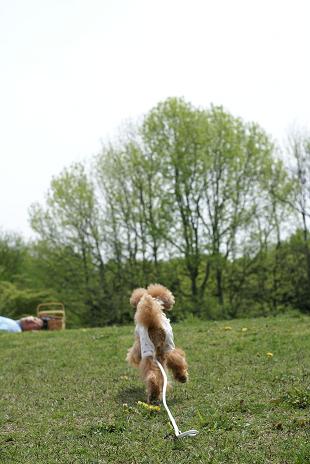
30 163 109 325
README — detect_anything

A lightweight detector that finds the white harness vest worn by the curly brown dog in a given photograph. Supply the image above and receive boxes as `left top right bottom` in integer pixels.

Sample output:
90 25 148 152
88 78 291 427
135 313 175 359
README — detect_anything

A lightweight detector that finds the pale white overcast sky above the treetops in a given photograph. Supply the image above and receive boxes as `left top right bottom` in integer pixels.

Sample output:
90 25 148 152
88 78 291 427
0 0 310 239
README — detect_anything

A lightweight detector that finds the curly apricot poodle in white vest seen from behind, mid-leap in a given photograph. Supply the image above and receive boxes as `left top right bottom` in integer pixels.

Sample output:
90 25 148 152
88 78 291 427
126 284 188 404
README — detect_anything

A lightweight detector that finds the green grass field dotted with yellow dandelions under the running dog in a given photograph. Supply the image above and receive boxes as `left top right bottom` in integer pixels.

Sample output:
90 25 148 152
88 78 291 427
0 316 310 464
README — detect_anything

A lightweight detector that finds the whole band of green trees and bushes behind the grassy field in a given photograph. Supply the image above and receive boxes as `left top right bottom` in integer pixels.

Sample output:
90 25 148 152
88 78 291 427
0 98 310 327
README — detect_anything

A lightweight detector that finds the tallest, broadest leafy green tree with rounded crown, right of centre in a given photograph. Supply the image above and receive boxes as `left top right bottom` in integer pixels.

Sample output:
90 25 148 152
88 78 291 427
142 99 280 314
